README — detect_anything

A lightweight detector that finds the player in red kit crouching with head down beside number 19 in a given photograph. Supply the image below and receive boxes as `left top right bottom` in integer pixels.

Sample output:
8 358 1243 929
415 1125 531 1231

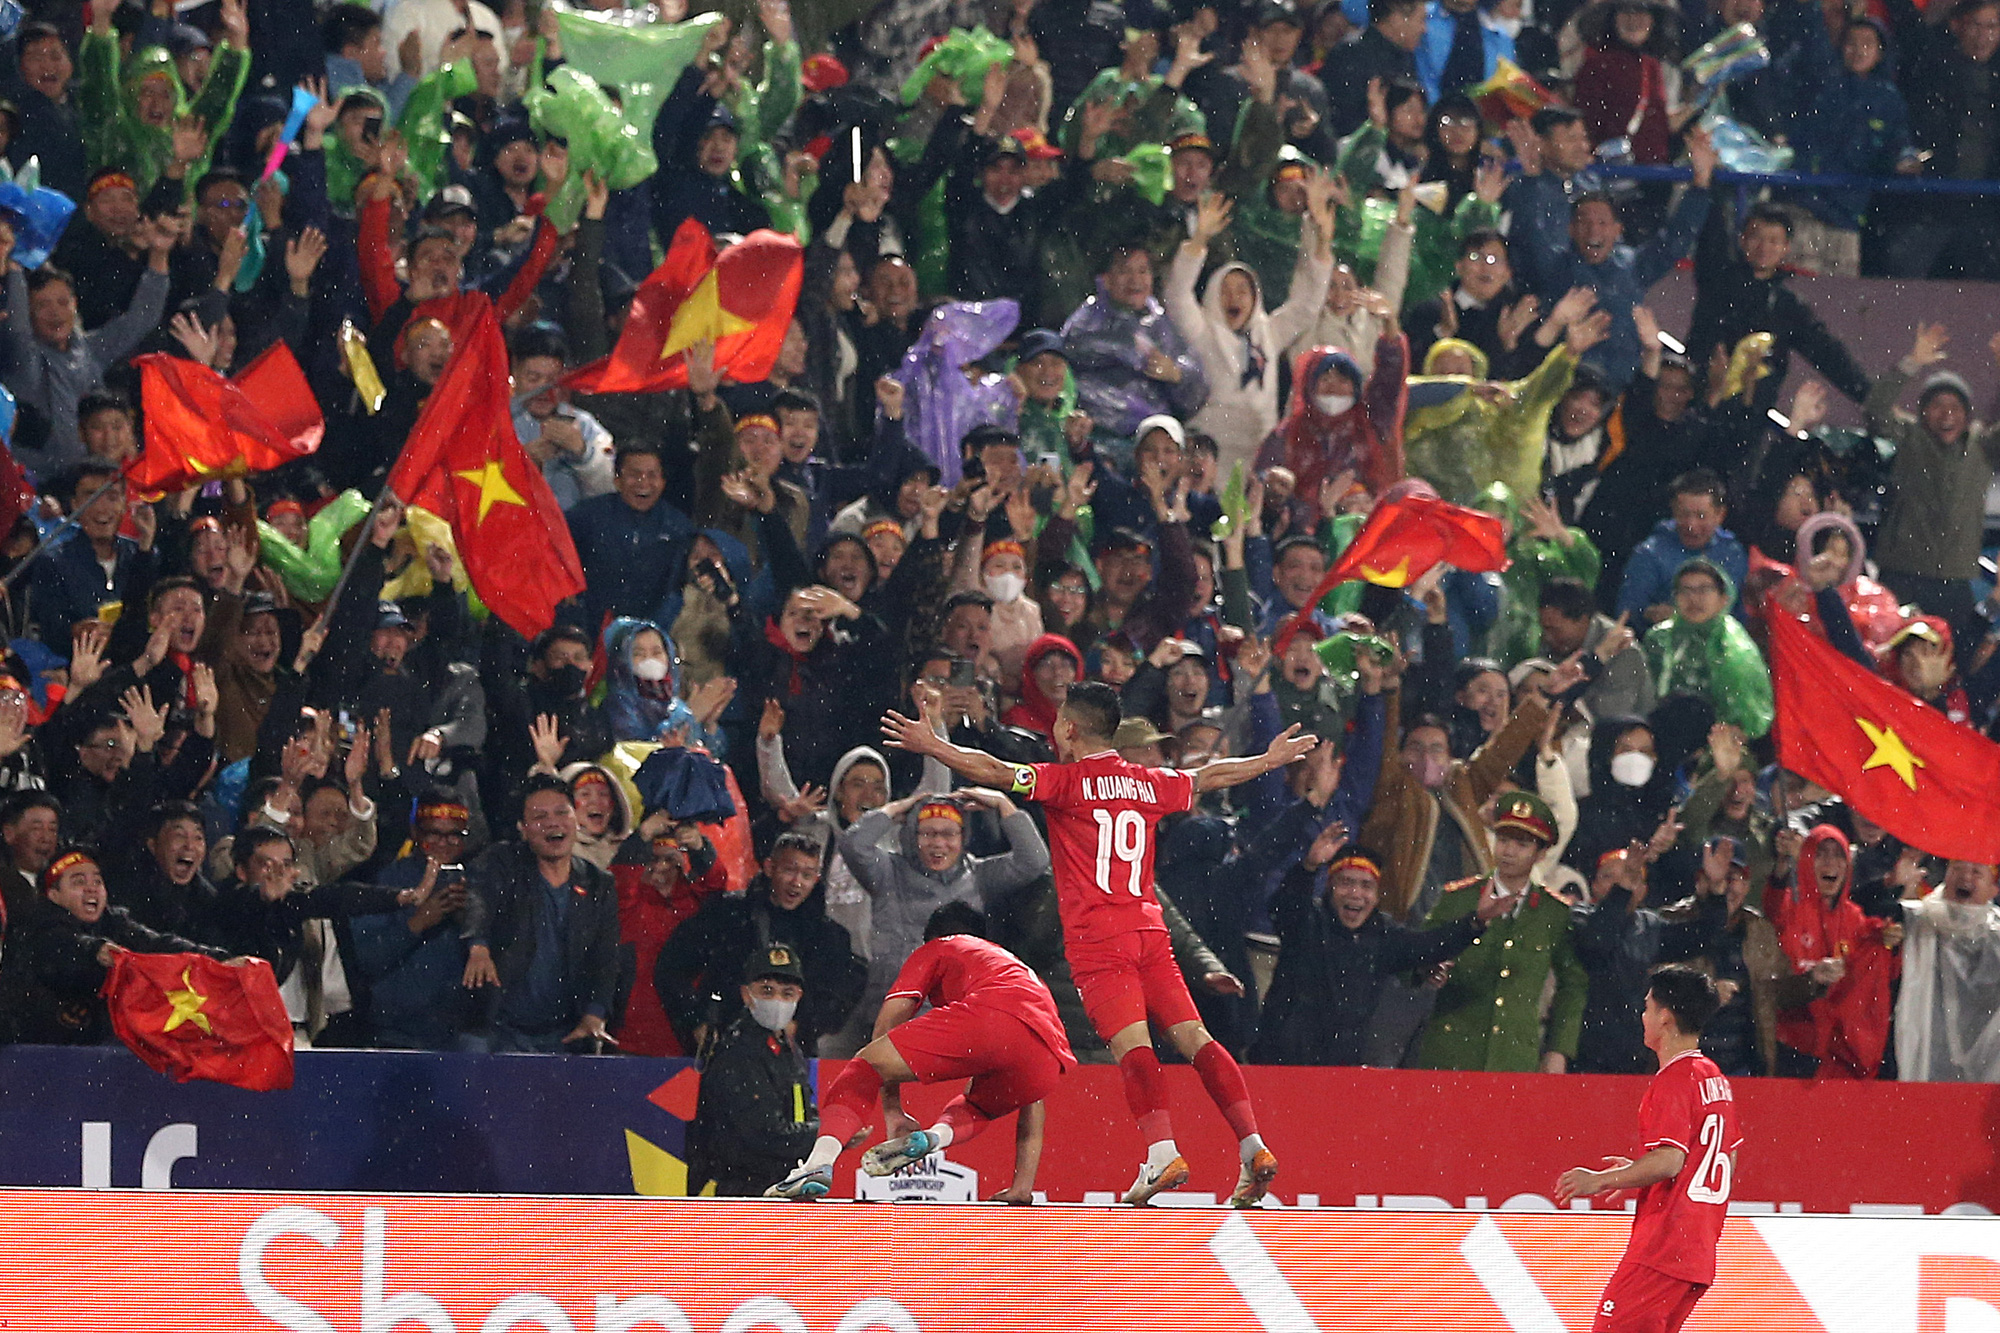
764 903 1076 1203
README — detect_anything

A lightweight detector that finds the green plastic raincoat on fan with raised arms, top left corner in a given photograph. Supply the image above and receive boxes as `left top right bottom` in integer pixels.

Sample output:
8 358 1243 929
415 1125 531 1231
78 32 250 198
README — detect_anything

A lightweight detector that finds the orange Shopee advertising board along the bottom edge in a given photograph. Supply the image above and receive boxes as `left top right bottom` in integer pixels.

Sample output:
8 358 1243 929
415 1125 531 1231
0 1189 2000 1333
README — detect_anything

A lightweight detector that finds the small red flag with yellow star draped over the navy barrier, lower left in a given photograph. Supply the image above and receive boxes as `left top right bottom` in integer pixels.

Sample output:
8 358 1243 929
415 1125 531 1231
104 949 292 1093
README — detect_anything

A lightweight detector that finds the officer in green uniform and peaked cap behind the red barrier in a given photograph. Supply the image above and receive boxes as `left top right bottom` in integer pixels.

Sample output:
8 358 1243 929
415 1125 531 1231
1418 791 1590 1073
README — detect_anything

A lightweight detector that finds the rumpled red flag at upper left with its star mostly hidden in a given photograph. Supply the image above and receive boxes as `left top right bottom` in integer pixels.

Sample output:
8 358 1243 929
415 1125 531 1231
126 342 326 492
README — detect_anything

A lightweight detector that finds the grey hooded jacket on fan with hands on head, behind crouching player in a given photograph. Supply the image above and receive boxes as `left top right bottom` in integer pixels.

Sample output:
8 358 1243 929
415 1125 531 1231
840 803 1050 1013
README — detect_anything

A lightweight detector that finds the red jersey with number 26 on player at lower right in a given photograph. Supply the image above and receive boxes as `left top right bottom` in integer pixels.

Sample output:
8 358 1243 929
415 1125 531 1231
1618 1051 1742 1285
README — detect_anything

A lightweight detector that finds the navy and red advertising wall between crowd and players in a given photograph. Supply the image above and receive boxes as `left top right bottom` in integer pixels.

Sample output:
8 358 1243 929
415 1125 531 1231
0 1047 2000 1208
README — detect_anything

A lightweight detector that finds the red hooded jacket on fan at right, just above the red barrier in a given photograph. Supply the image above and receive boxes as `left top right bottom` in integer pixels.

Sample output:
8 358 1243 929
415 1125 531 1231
1764 825 1902 1079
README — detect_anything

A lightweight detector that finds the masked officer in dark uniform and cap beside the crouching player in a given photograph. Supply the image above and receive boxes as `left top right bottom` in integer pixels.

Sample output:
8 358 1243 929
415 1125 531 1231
688 941 820 1197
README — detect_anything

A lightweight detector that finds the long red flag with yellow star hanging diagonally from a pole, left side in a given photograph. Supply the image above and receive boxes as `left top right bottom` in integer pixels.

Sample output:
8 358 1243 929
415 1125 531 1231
388 302 584 638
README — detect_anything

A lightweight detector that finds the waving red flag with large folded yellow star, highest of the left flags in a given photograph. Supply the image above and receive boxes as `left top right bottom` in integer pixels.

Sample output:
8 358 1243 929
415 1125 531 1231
564 218 806 394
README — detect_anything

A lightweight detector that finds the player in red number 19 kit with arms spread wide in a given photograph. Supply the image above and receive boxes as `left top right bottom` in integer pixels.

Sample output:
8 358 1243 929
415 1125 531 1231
882 683 1318 1209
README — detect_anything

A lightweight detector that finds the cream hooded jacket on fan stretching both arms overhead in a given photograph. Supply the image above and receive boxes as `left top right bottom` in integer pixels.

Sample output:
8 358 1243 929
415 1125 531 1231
1164 234 1334 472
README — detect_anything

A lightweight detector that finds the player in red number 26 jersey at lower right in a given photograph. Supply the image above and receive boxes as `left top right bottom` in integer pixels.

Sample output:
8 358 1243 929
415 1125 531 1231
1556 965 1742 1333
